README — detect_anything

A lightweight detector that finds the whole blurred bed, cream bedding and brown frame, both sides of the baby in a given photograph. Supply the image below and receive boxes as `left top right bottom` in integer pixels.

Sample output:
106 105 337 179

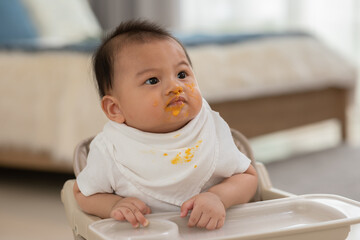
0 1 356 173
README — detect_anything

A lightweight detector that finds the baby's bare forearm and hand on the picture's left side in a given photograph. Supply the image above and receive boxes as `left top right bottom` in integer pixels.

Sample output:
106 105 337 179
74 182 151 227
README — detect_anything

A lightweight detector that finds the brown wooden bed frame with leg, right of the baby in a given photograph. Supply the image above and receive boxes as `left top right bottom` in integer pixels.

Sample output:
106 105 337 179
210 88 349 141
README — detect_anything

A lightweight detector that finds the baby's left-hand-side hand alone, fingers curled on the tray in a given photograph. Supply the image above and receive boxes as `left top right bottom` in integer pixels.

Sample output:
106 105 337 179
110 197 151 228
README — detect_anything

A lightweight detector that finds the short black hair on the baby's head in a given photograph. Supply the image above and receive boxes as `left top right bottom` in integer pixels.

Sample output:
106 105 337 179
93 20 191 98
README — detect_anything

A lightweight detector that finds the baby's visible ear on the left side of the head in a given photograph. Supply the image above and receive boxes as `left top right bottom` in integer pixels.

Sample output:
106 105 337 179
101 95 125 123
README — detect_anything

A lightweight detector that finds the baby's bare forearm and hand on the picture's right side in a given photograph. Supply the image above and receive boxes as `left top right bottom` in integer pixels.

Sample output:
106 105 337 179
180 165 257 230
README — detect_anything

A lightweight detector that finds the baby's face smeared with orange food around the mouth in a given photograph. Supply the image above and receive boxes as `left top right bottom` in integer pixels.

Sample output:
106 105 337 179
111 38 202 133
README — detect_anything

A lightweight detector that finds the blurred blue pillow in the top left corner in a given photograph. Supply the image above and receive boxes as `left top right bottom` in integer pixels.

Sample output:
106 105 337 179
0 0 37 44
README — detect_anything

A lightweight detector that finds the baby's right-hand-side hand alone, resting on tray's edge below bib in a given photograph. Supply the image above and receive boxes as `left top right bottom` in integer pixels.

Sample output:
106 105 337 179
180 192 226 230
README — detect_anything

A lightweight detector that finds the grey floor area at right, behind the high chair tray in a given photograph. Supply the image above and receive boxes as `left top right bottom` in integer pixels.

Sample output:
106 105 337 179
266 145 360 201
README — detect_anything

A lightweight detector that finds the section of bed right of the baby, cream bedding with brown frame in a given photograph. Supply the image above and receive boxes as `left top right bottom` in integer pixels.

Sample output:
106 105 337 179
184 32 356 140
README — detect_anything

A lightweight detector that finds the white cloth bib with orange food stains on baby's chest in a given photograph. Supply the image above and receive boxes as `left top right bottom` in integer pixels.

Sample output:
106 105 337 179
104 100 219 206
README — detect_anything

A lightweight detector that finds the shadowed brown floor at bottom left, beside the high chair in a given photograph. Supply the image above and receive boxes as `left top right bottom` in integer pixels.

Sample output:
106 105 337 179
0 169 73 240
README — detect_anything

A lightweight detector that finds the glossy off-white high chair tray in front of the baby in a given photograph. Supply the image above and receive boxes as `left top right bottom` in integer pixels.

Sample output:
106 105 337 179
89 194 360 240
